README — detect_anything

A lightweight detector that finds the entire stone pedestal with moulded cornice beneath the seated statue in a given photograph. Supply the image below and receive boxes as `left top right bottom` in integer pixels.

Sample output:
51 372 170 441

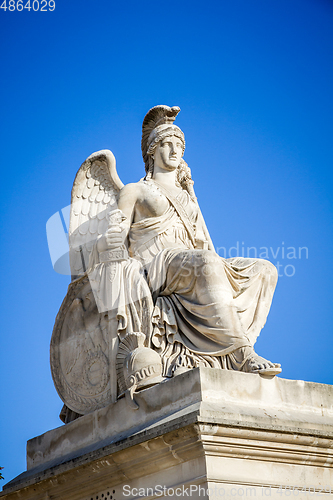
0 368 333 500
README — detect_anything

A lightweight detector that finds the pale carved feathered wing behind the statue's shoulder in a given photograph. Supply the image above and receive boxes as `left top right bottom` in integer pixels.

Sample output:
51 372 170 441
68 149 124 279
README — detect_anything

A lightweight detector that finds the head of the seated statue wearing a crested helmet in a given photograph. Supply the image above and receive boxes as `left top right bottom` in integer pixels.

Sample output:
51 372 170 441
141 105 185 178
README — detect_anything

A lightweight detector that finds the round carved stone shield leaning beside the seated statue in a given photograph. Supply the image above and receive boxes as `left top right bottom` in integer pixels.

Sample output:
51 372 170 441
50 275 111 415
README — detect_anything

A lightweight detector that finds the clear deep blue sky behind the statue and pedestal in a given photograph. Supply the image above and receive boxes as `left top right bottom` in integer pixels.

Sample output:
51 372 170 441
0 0 333 483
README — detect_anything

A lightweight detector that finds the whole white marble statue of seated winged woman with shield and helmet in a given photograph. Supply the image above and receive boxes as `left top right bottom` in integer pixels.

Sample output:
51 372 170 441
51 106 281 422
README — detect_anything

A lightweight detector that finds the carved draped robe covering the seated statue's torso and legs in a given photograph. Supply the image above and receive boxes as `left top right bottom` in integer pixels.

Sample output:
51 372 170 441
129 181 277 375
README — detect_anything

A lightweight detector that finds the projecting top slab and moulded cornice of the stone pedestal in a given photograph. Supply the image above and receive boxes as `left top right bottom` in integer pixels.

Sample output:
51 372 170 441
0 368 333 498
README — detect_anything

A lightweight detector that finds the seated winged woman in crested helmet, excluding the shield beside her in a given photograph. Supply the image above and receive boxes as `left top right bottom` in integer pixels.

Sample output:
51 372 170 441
51 105 281 422
